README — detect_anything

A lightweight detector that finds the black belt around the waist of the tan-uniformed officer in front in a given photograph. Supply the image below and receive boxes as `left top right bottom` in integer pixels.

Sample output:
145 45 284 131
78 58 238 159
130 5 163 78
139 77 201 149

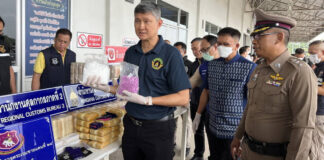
243 133 289 157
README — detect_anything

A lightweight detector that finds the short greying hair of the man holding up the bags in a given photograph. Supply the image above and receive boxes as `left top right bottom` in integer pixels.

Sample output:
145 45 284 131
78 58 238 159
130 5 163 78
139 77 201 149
134 1 161 20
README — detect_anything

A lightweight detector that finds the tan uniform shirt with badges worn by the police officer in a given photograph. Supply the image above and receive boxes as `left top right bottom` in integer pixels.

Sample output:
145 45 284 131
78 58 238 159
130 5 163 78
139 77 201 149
235 51 317 160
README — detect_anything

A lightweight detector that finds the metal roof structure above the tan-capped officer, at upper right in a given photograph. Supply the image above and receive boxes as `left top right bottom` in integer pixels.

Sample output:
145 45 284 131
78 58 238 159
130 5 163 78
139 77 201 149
246 0 324 42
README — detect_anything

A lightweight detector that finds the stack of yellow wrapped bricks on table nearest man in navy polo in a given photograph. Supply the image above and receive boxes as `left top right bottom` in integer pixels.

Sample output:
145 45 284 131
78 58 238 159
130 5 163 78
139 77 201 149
75 104 125 149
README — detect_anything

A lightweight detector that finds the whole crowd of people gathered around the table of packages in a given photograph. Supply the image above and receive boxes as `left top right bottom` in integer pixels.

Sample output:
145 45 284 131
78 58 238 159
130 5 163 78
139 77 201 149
0 2 324 160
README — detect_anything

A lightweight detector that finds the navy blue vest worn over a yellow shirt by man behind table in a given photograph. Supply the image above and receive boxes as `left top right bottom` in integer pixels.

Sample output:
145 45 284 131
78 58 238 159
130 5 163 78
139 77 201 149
40 46 75 89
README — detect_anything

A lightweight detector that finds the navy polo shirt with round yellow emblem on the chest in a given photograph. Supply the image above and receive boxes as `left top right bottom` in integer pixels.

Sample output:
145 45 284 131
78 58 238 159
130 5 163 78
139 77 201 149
124 36 190 120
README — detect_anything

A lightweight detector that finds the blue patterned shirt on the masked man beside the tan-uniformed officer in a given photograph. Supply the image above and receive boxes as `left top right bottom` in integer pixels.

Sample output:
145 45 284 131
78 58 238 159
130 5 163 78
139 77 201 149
205 54 256 139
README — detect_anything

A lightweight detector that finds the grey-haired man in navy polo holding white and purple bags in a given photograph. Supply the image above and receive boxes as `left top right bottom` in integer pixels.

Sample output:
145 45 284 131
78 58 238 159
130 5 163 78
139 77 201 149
85 2 190 160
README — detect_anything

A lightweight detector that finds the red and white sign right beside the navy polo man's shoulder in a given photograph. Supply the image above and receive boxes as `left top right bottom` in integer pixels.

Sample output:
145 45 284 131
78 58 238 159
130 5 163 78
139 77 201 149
105 46 128 63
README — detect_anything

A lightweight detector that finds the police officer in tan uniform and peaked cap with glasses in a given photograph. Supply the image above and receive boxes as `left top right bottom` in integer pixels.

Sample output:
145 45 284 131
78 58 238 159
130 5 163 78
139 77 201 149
231 9 317 160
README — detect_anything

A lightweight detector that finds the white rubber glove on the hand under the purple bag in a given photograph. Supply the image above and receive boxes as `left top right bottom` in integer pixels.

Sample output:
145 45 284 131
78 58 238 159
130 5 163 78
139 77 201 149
117 90 152 106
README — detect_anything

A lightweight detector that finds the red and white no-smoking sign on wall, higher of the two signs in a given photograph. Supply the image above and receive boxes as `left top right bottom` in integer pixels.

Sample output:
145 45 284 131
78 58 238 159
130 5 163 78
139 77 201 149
77 32 102 48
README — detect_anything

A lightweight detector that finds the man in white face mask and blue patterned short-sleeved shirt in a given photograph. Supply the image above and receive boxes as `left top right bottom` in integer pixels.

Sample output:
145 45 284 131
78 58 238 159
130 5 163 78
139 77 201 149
193 27 256 160
